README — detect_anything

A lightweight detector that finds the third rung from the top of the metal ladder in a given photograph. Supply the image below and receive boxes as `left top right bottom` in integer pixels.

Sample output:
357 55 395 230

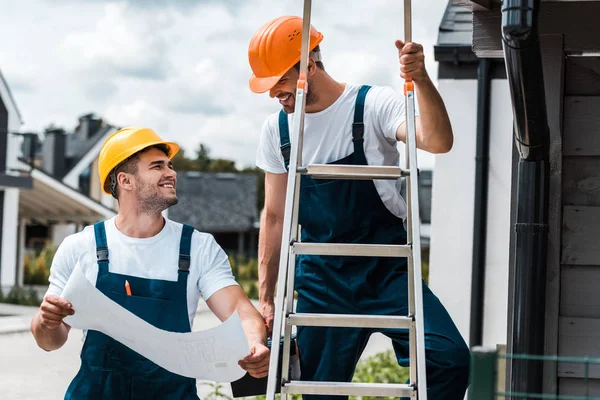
287 313 413 329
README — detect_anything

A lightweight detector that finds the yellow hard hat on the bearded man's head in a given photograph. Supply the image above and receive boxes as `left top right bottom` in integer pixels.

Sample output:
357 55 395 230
98 127 179 194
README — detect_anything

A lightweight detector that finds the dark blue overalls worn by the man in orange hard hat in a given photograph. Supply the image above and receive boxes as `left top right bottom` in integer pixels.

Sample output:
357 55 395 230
279 86 469 400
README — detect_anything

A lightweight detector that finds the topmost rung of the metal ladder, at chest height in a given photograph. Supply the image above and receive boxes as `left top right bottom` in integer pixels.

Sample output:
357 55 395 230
298 164 409 180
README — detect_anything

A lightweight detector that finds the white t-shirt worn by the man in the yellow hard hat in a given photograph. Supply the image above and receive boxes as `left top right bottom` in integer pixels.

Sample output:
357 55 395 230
47 218 237 326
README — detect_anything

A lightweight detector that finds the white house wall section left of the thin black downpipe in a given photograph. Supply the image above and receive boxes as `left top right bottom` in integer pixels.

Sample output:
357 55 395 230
429 79 477 341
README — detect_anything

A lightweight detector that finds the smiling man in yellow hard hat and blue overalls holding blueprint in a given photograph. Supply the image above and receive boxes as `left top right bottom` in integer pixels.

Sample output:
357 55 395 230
31 127 269 399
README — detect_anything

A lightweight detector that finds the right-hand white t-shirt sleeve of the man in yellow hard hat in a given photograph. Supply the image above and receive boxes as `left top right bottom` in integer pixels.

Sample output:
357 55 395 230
196 233 238 300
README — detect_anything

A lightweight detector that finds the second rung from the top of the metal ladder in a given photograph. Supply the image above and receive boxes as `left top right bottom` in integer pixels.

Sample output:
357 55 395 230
293 243 412 257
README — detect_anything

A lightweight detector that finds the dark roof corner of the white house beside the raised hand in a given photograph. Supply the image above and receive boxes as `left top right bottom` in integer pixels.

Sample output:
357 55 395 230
434 0 477 62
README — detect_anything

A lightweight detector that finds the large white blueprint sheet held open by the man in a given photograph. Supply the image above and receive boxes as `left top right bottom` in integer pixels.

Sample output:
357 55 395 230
61 266 250 382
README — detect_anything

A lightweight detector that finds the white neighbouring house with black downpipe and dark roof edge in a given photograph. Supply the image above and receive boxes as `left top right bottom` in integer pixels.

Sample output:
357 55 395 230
429 3 514 354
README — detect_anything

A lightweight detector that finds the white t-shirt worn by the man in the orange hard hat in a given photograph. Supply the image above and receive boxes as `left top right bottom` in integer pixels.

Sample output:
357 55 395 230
256 84 406 218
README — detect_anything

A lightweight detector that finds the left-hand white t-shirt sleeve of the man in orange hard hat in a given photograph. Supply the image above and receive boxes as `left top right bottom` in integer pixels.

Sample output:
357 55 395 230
256 115 287 174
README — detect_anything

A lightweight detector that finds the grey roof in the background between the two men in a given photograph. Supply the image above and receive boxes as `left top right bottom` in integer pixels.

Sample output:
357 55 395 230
169 171 258 233
